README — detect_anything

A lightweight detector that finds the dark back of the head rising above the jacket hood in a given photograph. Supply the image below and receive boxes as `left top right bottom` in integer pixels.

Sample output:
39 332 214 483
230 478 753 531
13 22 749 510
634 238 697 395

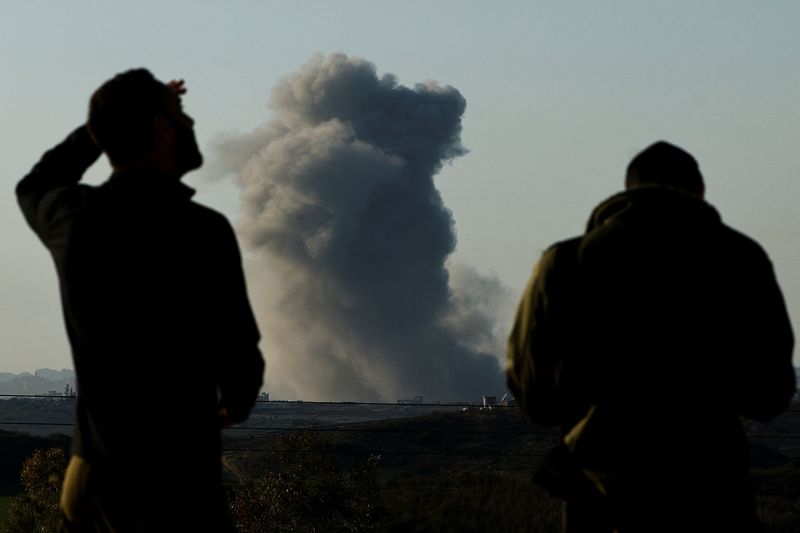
625 141 705 198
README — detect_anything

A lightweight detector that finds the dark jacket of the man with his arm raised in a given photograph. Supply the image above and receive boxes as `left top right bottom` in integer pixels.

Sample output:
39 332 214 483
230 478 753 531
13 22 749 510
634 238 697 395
17 127 264 485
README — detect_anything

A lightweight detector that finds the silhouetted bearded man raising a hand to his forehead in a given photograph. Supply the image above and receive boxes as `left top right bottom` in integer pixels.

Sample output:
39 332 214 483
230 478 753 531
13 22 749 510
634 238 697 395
17 69 264 532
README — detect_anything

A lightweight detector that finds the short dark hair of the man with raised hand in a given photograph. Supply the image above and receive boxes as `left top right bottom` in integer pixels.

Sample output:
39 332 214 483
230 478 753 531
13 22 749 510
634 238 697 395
87 68 169 163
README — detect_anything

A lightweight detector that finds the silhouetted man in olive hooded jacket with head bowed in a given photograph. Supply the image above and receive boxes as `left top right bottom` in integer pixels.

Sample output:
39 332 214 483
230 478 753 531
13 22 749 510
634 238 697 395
508 142 795 533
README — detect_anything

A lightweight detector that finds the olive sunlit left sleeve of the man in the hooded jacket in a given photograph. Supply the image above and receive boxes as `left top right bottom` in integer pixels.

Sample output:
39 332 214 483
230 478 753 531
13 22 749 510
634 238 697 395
506 247 561 425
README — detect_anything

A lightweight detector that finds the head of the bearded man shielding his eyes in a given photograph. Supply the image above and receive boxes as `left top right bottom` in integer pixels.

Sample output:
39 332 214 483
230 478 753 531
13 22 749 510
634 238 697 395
88 69 203 177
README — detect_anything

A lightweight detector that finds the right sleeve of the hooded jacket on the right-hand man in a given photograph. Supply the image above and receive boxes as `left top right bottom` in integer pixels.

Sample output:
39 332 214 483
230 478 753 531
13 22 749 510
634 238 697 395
732 247 796 420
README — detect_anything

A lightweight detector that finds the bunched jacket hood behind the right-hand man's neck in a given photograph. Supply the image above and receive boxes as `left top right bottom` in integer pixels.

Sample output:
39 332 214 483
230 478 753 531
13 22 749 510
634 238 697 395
586 186 722 233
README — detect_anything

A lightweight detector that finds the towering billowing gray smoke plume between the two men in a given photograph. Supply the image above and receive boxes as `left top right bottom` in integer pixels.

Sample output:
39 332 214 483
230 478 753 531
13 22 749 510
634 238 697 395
220 54 504 401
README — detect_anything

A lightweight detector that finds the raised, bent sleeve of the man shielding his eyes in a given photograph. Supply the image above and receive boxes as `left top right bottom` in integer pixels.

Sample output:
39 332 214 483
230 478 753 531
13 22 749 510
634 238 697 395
16 126 102 243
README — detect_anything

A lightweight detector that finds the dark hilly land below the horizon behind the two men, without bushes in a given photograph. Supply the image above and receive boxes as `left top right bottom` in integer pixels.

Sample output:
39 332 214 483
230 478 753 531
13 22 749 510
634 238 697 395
0 398 800 533
